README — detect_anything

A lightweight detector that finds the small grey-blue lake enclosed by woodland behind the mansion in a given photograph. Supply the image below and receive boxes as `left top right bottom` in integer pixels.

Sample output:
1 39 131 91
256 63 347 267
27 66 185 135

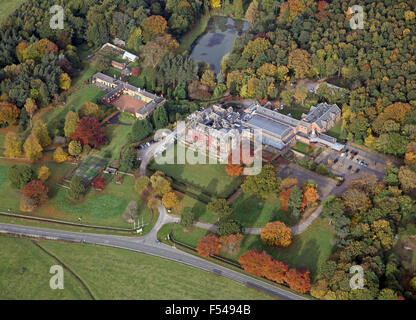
191 16 250 73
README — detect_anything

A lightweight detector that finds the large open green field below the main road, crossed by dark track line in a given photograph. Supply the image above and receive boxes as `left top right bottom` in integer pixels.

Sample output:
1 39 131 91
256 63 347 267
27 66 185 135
0 236 270 300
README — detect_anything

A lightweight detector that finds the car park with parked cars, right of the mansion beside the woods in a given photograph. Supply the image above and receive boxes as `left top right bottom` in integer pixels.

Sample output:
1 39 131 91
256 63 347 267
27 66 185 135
316 146 387 179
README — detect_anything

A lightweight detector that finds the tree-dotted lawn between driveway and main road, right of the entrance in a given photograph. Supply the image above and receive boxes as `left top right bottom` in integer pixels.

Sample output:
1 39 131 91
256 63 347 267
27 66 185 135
159 220 335 279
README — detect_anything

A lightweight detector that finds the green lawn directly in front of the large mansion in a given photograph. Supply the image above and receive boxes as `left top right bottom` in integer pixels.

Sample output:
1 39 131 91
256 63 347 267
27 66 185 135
149 144 242 198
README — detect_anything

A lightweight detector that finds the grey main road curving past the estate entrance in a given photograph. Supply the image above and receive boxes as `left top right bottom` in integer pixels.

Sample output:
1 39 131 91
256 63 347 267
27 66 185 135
0 223 307 300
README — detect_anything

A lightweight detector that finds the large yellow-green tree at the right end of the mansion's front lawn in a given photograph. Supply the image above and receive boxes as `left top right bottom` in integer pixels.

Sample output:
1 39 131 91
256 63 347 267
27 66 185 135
241 164 279 199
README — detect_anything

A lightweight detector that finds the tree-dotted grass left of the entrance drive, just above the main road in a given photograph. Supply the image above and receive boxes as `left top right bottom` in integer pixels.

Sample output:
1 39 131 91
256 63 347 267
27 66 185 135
0 160 153 228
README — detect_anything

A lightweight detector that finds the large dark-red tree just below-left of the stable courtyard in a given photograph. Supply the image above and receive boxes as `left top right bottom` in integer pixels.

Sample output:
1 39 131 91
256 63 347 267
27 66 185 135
70 118 105 147
